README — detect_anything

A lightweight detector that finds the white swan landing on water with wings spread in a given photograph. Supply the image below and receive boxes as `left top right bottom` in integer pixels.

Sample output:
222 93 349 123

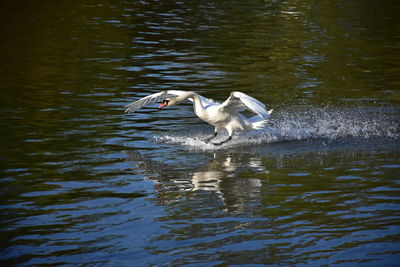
125 90 273 146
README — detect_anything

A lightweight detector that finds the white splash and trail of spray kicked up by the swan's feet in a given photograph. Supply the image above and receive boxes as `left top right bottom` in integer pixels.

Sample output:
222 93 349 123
155 107 400 150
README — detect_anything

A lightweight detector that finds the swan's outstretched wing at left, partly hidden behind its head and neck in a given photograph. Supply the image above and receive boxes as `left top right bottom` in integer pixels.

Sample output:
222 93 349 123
125 90 218 113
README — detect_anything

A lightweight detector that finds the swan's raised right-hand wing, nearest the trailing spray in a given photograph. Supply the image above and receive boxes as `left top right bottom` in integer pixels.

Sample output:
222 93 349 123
221 92 272 119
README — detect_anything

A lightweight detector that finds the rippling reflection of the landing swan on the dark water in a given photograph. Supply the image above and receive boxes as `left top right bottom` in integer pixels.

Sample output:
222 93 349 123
126 150 269 211
